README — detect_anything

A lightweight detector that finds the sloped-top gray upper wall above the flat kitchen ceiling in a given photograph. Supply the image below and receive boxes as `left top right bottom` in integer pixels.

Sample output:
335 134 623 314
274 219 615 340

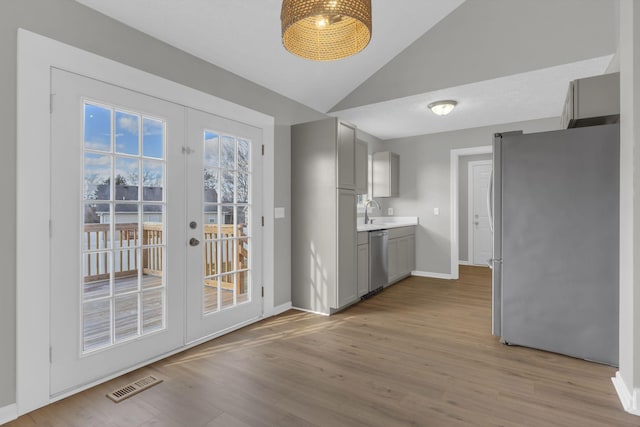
332 0 617 111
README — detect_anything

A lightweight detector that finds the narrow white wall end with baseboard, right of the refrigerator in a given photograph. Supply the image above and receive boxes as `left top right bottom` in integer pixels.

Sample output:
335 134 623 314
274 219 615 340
614 0 640 415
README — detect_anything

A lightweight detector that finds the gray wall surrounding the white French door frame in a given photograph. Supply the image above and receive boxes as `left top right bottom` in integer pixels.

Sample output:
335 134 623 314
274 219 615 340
0 0 324 408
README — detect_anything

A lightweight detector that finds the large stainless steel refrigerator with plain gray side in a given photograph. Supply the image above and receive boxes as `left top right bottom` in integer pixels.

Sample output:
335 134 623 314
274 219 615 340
490 124 620 366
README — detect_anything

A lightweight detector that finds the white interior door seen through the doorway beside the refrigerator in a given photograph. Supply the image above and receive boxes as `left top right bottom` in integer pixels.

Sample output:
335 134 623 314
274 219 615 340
468 160 493 266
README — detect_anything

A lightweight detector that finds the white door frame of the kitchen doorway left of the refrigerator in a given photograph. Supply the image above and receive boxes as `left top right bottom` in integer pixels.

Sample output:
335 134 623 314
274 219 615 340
449 145 493 280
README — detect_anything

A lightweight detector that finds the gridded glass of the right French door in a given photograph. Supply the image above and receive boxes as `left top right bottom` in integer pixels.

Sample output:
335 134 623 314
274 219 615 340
202 130 251 314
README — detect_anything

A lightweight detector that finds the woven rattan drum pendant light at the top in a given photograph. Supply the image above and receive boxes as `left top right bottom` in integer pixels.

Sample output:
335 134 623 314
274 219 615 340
280 0 371 61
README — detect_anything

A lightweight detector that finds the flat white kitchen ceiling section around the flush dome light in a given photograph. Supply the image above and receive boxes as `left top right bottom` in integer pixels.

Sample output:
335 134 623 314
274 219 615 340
329 55 613 139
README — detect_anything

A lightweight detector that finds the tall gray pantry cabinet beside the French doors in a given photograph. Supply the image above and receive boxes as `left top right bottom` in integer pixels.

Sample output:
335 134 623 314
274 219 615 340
291 118 358 314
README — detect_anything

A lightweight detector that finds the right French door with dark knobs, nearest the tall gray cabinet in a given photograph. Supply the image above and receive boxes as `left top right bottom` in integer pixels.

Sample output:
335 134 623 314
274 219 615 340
187 110 262 342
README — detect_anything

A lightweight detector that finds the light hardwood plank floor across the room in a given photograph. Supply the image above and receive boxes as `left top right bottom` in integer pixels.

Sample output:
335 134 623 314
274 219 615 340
9 266 640 427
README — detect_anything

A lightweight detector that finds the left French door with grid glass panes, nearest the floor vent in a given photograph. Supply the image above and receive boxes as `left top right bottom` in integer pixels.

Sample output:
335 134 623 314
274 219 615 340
50 70 186 395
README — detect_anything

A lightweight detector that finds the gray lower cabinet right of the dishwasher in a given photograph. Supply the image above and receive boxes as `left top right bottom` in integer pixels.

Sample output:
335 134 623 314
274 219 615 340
387 226 416 285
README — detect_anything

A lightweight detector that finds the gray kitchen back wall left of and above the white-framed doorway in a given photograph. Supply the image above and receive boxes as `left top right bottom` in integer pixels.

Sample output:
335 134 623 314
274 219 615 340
384 118 560 274
